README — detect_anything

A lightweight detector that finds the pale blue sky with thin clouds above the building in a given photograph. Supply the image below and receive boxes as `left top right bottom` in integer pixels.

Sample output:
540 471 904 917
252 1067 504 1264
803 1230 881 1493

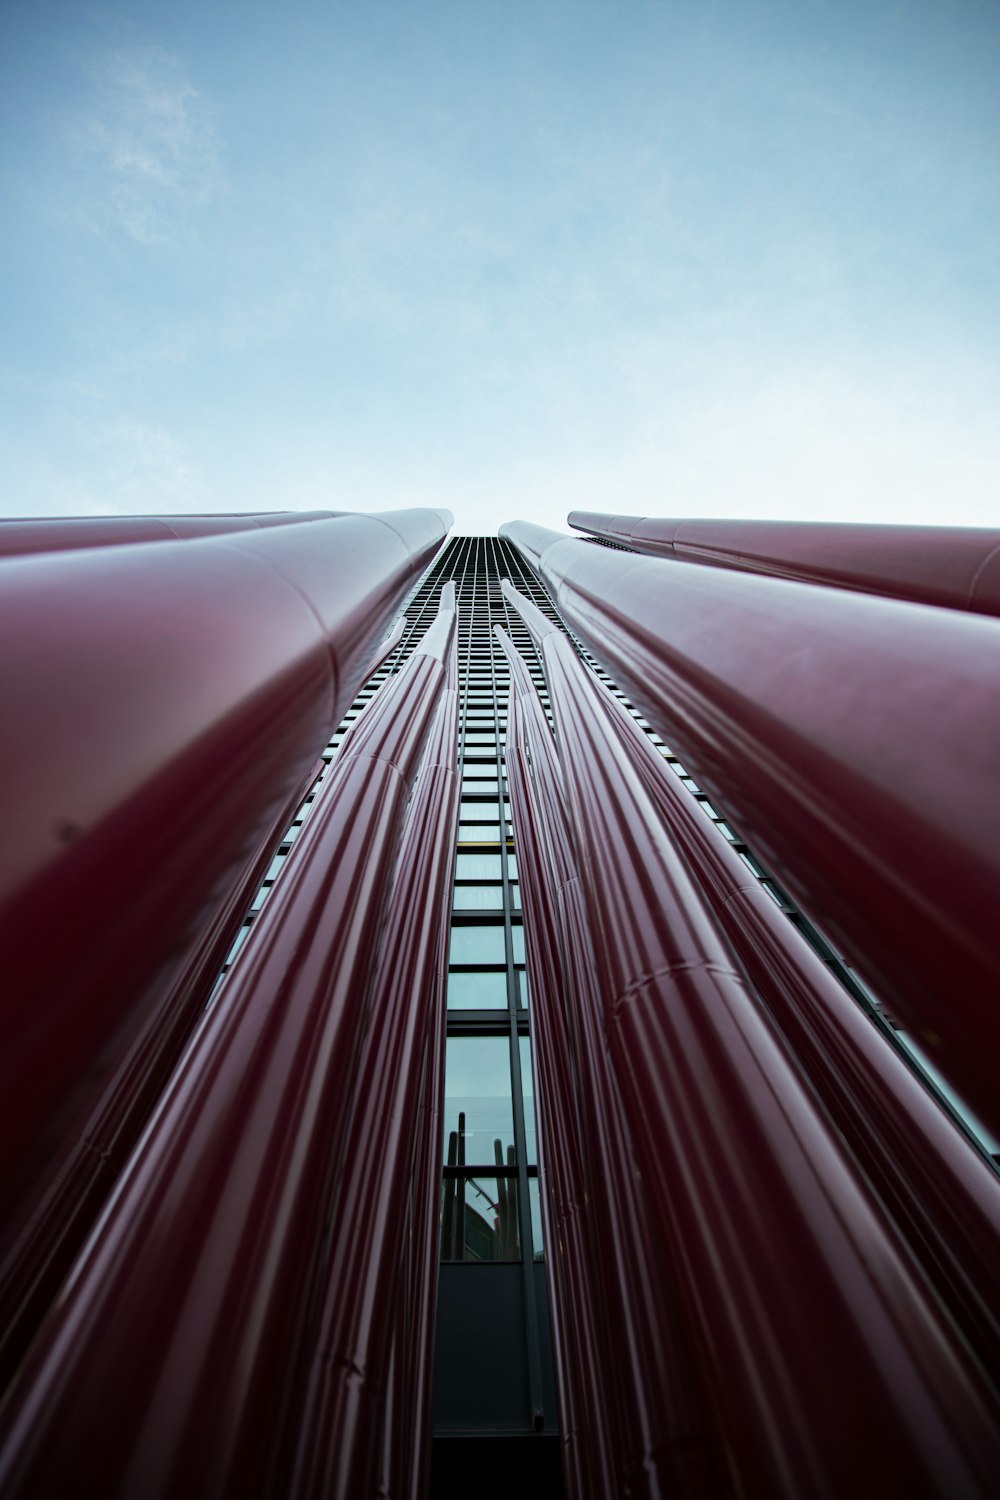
0 0 1000 533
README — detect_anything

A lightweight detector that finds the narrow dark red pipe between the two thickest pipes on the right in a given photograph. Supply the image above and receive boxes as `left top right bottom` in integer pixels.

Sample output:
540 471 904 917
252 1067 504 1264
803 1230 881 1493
600 689 1000 1386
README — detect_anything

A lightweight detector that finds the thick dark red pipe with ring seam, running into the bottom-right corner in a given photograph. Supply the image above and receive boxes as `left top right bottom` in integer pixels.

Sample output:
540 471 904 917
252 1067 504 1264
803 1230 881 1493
500 579 1000 1497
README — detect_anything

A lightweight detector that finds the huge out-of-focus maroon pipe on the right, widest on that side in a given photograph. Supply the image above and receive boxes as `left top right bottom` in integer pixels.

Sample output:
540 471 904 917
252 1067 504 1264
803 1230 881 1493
505 522 1000 1131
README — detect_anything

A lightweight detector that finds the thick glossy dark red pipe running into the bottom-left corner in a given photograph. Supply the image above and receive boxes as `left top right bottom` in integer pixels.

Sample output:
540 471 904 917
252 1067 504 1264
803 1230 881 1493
0 597 453 1500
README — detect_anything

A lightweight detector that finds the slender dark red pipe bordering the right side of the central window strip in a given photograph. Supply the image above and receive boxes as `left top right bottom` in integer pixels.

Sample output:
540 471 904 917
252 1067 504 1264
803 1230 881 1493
498 630 735 1496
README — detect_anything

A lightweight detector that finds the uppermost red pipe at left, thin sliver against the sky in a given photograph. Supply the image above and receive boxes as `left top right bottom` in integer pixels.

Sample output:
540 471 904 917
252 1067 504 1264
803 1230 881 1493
0 510 349 558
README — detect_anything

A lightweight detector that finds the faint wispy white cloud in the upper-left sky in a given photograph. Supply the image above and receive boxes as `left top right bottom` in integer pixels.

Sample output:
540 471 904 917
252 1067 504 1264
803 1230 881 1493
73 47 222 245
